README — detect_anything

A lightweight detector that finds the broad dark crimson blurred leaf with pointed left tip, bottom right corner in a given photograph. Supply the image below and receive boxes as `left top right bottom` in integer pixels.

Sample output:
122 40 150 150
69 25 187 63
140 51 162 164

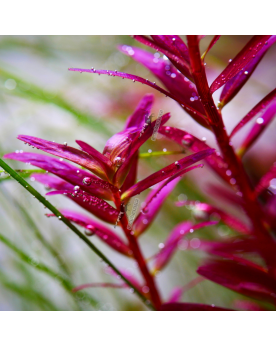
197 260 276 303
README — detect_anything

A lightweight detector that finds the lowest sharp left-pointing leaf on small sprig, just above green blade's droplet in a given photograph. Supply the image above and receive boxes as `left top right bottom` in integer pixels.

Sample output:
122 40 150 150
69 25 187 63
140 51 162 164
48 210 132 256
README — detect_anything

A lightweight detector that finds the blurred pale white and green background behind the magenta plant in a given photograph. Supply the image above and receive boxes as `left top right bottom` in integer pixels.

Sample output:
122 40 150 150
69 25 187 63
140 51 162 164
0 36 276 310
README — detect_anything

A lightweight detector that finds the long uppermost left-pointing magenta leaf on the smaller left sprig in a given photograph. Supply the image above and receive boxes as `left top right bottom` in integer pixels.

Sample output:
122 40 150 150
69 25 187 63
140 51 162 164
17 135 107 180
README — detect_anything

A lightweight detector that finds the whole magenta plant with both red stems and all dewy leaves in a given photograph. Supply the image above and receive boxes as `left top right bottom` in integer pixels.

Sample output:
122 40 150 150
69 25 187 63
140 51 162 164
4 35 276 310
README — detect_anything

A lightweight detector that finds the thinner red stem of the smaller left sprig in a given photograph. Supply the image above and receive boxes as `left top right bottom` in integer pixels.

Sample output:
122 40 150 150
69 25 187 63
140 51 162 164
113 192 162 310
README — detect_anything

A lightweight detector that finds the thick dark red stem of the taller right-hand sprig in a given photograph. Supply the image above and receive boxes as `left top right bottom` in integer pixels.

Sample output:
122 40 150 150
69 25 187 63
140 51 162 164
187 35 276 274
